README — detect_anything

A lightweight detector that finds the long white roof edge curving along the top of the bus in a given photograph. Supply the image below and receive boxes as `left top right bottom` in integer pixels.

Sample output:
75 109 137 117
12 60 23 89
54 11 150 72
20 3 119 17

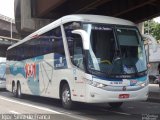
8 14 135 49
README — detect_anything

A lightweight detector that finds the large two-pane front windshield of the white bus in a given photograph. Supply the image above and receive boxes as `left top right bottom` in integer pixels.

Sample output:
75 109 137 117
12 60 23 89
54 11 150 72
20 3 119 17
83 24 147 76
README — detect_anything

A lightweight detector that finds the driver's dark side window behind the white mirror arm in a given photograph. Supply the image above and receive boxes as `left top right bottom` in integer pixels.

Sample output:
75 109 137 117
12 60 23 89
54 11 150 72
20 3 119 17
64 22 84 69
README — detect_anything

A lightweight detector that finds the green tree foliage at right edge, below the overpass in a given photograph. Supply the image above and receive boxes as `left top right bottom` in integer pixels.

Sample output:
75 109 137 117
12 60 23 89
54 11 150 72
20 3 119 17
144 20 160 40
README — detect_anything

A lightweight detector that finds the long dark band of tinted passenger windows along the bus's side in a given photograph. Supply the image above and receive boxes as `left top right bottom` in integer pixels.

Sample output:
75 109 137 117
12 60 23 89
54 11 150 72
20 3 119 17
7 27 65 61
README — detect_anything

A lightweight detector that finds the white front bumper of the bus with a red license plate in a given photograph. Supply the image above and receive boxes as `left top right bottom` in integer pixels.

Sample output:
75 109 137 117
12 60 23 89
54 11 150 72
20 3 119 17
86 85 148 103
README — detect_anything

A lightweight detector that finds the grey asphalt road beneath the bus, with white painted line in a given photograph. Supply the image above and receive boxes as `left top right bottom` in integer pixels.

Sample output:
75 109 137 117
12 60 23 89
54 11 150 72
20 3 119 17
0 91 160 120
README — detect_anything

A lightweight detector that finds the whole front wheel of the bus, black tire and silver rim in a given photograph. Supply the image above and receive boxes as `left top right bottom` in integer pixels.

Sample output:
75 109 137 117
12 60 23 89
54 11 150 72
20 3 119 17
61 84 73 109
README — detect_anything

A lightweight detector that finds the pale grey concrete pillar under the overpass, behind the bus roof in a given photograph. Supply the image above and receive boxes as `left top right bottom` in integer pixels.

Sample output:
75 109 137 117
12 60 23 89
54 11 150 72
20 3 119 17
21 0 51 32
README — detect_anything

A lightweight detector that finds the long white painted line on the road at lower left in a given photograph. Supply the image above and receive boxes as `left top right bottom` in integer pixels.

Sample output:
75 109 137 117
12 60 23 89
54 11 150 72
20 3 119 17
0 96 63 114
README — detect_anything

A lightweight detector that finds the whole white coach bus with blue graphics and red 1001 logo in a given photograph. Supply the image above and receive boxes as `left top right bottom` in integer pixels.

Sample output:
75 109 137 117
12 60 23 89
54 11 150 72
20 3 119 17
6 15 148 109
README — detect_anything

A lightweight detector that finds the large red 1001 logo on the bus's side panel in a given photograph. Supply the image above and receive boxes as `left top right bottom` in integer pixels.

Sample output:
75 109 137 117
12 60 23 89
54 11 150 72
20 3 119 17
25 63 36 79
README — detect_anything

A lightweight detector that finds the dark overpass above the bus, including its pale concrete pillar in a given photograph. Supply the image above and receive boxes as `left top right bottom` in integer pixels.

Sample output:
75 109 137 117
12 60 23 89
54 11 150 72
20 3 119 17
15 0 160 34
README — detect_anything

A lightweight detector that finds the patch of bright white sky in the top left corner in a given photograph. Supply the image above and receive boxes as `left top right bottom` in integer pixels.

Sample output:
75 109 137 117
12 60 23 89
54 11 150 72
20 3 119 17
0 0 14 18
